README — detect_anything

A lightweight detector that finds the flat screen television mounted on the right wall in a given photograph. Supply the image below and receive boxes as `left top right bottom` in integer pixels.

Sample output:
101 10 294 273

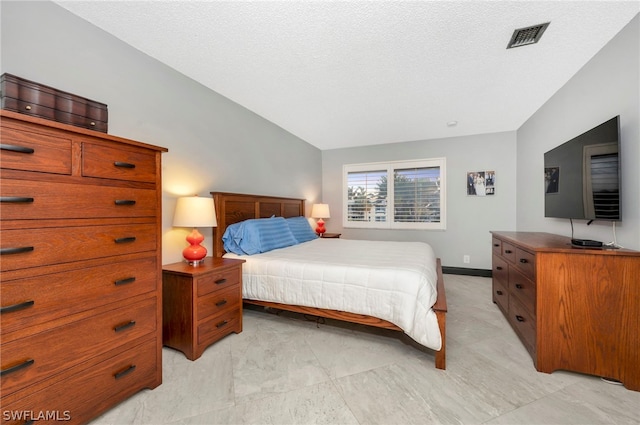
544 116 622 221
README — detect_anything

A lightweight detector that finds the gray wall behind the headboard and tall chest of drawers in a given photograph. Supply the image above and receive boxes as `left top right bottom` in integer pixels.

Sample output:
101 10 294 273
0 1 322 264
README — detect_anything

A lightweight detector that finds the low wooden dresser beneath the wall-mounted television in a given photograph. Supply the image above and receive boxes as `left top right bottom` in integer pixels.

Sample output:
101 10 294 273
491 232 640 391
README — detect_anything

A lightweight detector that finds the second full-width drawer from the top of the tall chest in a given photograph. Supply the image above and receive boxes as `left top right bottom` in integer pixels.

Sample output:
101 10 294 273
0 224 158 271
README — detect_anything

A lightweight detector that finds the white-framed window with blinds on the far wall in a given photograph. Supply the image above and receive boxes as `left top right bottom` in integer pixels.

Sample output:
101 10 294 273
343 158 446 229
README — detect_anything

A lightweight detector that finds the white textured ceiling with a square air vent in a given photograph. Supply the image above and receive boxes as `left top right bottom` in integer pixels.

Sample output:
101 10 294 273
55 0 640 149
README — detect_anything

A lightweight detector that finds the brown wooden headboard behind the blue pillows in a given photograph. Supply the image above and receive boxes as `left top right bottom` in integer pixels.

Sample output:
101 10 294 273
211 192 305 257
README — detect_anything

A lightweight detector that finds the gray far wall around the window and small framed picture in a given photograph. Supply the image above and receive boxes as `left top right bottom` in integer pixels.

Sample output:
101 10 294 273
322 132 516 269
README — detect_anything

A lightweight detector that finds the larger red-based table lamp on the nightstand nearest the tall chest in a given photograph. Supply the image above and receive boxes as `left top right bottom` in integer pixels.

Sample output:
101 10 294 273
173 196 218 266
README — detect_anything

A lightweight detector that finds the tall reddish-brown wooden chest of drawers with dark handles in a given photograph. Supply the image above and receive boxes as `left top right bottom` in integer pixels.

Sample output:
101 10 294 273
0 111 166 423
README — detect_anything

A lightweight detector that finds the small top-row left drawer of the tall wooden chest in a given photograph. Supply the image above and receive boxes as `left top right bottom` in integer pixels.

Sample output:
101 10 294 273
0 122 72 175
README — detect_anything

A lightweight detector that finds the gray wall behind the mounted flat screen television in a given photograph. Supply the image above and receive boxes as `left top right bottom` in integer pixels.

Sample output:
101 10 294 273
516 16 640 250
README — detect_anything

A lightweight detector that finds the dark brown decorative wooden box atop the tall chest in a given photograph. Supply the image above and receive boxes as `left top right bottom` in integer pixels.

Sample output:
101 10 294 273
0 74 108 133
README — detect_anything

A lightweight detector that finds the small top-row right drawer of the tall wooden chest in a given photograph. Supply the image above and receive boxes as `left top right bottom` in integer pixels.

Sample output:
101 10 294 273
82 143 157 183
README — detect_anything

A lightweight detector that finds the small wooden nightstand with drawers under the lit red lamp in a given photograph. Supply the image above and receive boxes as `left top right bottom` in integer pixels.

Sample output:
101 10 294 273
162 257 244 360
